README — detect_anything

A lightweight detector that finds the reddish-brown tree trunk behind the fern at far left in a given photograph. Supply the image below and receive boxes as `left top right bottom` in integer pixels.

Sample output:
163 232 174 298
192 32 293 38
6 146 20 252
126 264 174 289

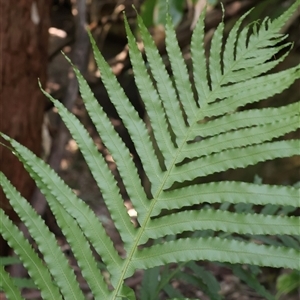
0 0 51 255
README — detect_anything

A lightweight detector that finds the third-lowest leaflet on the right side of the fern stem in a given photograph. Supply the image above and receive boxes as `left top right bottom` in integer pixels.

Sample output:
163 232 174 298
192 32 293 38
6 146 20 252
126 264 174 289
152 181 299 216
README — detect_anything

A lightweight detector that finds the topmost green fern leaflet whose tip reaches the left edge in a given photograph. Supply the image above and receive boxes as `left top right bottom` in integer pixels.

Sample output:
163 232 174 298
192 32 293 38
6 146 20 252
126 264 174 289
2 135 122 286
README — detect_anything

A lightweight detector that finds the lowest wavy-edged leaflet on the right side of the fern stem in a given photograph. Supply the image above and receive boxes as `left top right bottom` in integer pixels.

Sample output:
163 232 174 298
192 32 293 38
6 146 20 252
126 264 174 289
127 237 299 276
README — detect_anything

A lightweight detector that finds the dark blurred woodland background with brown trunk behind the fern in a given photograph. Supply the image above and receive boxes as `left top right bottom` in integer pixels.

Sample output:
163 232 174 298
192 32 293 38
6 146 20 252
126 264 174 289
0 0 300 299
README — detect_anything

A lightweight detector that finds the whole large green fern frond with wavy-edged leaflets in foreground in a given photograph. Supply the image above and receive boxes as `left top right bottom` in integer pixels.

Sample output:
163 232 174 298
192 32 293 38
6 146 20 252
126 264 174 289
0 1 300 300
